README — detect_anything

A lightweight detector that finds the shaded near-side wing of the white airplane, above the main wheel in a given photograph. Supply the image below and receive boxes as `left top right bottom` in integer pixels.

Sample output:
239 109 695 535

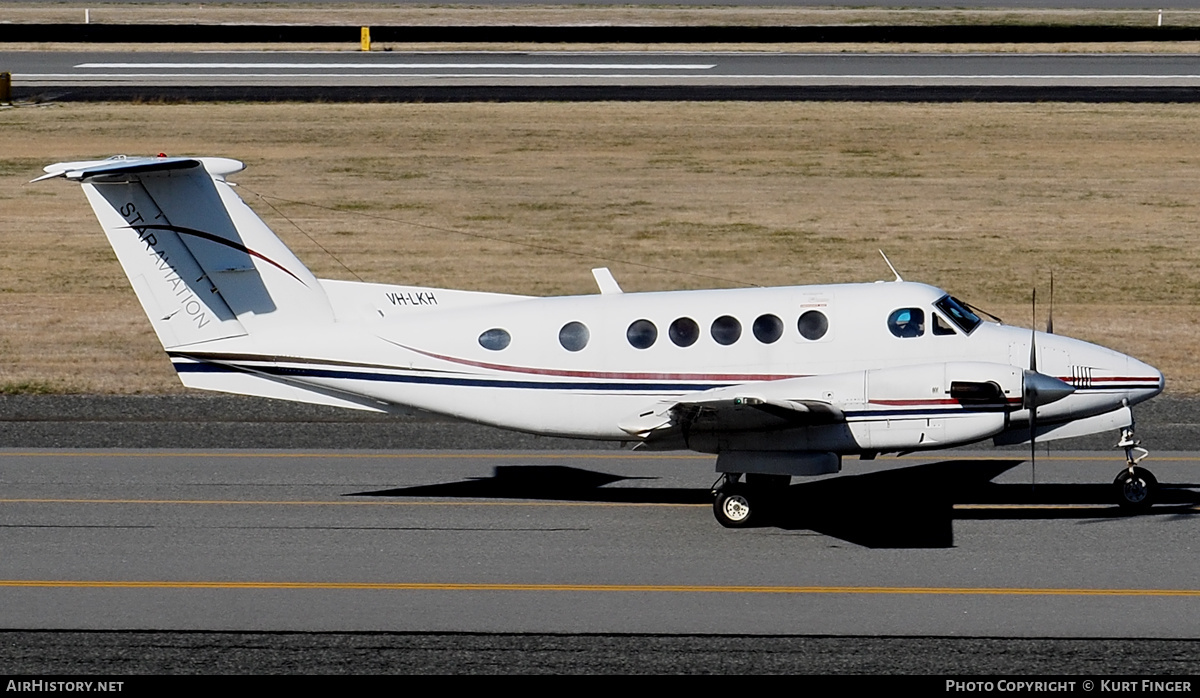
620 396 846 439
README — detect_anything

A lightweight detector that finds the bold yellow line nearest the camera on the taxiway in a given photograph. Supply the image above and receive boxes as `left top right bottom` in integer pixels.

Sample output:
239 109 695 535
0 579 1200 597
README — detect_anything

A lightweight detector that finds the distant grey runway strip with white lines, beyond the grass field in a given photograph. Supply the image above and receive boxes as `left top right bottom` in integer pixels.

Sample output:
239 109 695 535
9 52 1200 89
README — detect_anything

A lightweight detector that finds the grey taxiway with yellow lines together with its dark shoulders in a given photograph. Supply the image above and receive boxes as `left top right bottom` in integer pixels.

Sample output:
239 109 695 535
0 395 1200 674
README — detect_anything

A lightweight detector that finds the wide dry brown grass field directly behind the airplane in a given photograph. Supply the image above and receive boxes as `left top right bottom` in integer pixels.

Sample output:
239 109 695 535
0 103 1200 393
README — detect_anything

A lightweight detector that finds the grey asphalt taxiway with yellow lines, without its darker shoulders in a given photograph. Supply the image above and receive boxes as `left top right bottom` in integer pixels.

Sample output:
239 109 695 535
0 450 1200 638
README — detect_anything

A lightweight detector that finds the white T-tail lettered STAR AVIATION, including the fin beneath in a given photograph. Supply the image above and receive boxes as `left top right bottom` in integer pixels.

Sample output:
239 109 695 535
35 156 377 409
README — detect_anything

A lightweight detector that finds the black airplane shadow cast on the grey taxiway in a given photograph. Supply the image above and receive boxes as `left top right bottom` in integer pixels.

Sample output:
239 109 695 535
346 459 1200 548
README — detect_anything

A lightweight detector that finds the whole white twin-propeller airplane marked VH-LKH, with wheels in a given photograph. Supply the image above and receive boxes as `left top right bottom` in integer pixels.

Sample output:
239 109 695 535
34 156 1163 526
